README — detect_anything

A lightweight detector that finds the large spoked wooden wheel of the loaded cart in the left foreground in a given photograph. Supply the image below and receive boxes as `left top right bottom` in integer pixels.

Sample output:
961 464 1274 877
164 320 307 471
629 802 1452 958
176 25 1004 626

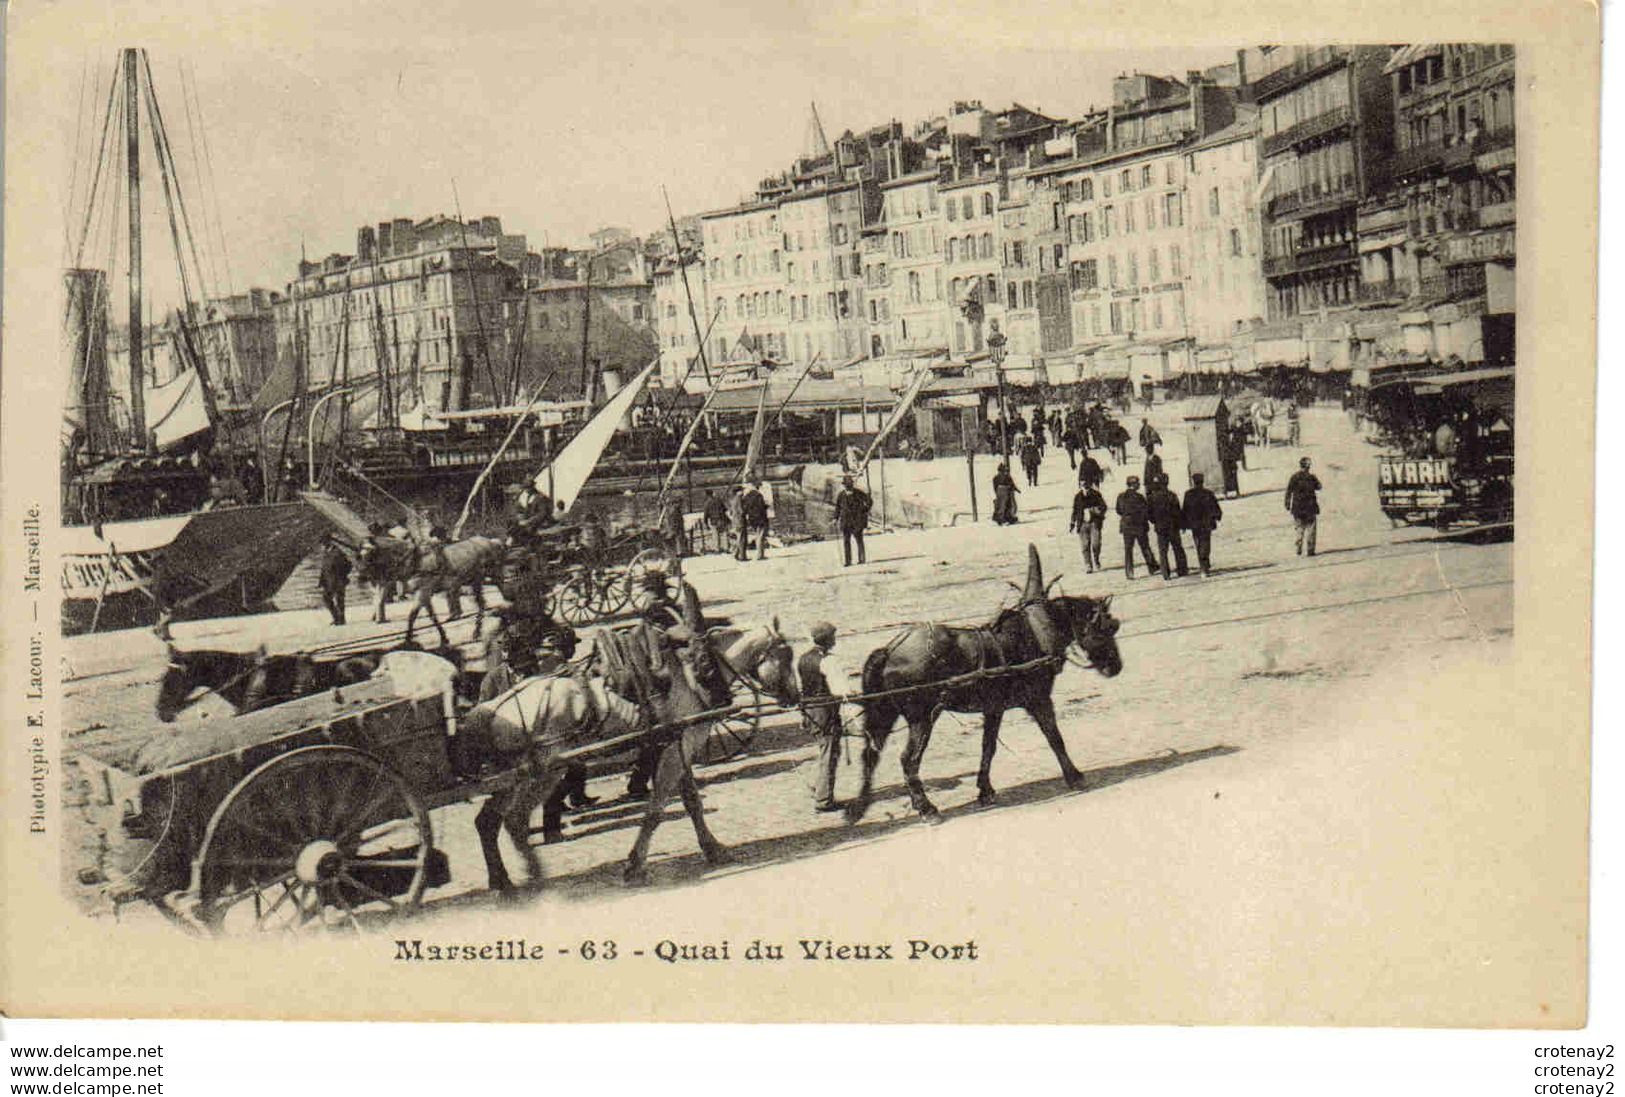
192 744 434 934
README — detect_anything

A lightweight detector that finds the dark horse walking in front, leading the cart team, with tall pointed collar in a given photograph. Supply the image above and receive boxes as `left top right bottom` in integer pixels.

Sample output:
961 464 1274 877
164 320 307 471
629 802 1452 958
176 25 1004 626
847 544 1123 822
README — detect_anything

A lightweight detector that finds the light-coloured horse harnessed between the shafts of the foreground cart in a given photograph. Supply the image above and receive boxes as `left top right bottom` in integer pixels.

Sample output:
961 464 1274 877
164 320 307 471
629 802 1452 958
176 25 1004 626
458 583 795 894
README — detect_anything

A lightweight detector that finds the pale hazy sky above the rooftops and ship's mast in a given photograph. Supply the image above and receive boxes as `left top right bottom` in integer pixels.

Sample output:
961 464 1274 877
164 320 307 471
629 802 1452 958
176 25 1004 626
52 0 1240 310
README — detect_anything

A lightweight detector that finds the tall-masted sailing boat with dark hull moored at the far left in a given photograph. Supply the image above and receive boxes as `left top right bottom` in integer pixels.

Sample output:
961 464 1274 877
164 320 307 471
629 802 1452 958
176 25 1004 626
59 49 330 634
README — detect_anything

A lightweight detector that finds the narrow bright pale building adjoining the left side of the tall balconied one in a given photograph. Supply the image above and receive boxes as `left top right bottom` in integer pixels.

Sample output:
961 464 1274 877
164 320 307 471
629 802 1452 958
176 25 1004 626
1168 114 1268 364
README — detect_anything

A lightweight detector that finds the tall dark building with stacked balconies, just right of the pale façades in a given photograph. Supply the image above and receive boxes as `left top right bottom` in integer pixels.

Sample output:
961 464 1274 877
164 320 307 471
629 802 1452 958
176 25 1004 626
1242 46 1393 319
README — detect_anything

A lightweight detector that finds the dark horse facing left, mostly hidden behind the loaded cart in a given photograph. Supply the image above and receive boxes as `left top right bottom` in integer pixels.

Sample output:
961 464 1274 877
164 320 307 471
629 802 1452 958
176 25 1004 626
154 645 384 723
